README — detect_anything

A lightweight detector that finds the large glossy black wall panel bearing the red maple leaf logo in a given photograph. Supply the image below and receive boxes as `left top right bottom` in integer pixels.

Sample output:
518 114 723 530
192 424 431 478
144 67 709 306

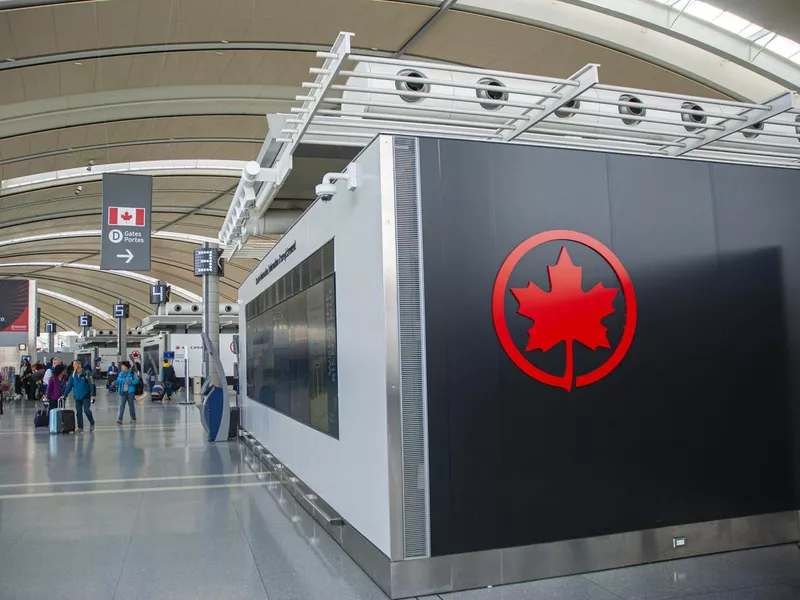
420 140 800 556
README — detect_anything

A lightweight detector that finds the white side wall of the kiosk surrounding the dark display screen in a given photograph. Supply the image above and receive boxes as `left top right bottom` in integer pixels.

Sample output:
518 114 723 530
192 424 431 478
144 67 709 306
239 138 390 556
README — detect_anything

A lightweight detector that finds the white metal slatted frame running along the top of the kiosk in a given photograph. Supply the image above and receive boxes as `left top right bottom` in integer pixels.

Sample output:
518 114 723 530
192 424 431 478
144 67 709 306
219 33 800 254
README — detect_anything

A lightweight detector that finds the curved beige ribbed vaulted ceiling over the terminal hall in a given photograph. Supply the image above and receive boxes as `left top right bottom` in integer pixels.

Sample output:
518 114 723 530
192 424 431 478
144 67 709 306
0 0 782 322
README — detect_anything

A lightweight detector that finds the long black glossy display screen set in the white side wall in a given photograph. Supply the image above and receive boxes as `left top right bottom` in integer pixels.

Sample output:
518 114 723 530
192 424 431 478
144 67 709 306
247 275 339 438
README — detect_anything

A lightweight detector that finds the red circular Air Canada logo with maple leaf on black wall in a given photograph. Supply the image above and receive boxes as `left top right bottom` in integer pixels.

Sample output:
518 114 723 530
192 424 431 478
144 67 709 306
492 230 636 391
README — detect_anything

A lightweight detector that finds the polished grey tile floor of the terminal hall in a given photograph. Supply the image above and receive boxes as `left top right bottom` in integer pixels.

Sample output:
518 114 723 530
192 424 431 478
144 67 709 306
0 390 800 600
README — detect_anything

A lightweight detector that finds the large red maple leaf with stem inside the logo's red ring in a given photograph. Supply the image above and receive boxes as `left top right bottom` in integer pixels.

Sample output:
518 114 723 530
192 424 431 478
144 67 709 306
511 246 619 391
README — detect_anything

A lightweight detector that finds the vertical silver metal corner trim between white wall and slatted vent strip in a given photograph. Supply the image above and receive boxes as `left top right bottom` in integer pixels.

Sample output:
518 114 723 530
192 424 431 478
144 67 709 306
378 135 404 560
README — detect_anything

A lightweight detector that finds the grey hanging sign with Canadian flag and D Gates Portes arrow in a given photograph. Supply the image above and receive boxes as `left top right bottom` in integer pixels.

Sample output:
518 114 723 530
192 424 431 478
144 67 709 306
100 173 153 271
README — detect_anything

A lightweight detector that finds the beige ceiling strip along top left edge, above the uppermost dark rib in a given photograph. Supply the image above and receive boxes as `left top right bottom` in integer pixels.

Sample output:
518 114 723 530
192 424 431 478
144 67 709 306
0 0 435 58
